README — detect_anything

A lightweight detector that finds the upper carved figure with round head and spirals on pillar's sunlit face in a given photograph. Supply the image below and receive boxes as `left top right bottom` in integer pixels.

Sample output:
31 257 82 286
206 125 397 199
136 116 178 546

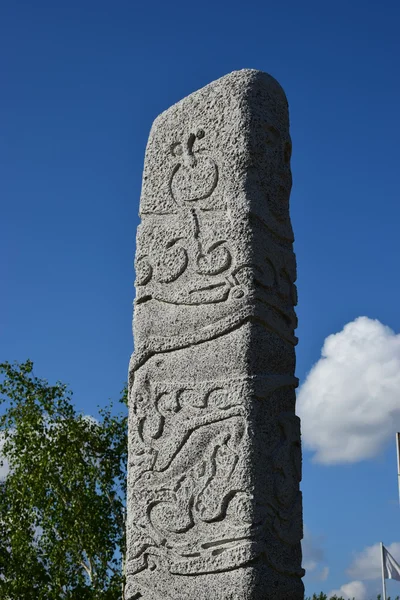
136 129 234 305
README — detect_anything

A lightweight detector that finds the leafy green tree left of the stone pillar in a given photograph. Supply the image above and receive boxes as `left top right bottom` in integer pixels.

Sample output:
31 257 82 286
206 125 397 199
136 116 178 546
0 361 127 600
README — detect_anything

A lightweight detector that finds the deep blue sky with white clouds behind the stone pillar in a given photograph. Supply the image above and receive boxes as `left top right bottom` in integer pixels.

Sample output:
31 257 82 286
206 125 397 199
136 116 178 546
0 0 400 600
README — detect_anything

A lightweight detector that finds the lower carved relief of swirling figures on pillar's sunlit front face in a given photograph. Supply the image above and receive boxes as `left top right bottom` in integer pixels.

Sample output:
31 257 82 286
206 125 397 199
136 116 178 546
128 381 260 574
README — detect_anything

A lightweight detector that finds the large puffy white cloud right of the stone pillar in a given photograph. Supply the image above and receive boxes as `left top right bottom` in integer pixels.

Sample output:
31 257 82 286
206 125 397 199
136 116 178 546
297 317 400 464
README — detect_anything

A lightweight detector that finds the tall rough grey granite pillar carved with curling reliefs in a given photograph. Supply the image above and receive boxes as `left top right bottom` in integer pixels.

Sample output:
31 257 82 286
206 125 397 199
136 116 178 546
126 69 304 600
